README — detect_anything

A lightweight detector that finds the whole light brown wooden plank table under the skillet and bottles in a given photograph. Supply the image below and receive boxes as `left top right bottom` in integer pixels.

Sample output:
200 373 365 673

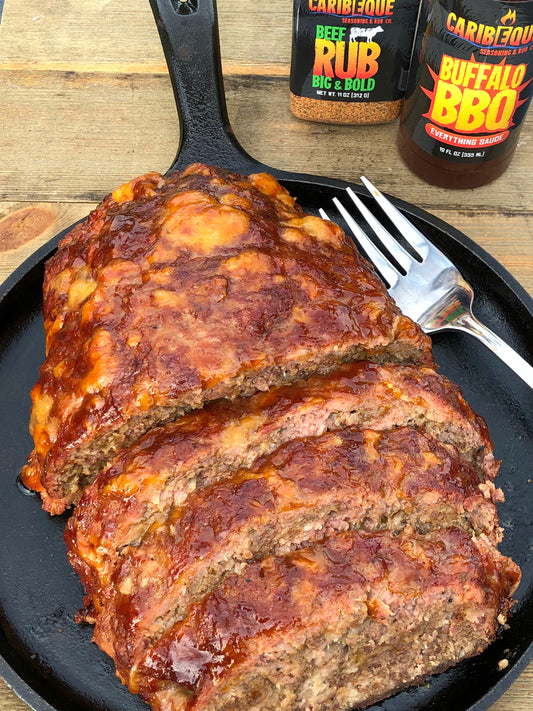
0 0 533 711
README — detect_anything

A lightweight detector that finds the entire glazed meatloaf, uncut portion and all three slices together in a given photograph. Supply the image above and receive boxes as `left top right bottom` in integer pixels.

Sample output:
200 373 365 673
24 164 520 711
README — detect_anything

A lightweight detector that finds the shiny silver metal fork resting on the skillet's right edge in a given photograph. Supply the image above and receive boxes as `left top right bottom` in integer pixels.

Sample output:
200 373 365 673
320 177 533 388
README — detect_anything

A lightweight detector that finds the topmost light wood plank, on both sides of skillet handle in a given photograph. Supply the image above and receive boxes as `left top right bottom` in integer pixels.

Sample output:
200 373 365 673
0 0 292 73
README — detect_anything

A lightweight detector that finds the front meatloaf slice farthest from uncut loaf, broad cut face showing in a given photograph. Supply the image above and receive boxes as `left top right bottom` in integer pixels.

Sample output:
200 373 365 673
130 529 520 711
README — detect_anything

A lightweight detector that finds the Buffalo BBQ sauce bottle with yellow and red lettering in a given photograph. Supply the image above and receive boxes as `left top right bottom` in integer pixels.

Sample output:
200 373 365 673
398 0 533 188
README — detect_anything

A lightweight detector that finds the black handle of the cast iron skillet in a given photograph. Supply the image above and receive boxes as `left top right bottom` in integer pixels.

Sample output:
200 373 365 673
150 0 265 173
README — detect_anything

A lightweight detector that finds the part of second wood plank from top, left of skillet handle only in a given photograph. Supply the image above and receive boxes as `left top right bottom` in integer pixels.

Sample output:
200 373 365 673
0 71 178 202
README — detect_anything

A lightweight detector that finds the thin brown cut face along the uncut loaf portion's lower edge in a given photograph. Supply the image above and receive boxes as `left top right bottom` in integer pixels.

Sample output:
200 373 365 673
39 341 430 513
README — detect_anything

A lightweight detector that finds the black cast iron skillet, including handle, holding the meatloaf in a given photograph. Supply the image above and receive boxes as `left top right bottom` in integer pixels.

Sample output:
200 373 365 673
0 0 533 711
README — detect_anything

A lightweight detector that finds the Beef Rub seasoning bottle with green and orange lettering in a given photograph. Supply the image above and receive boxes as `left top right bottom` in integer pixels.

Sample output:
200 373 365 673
290 0 419 124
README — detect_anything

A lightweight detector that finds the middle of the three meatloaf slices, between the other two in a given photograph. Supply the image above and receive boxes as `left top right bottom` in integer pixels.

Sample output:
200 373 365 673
88 428 501 680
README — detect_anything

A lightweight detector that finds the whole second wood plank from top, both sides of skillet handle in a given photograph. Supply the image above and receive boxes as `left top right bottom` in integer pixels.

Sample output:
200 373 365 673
0 70 533 215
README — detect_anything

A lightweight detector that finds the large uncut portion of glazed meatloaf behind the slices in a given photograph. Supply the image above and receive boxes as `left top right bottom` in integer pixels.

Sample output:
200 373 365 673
23 164 433 513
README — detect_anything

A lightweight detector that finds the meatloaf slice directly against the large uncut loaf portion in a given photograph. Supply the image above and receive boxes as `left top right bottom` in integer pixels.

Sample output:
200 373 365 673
66 362 498 587
